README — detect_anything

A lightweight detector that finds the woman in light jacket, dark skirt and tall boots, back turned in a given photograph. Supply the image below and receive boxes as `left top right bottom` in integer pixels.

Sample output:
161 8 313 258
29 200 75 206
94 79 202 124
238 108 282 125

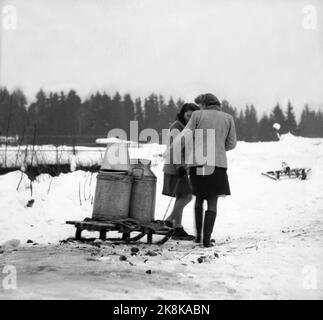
172 93 237 247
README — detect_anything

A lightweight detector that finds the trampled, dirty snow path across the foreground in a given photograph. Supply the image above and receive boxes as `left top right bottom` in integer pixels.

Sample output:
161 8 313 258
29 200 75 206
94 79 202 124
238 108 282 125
0 234 323 300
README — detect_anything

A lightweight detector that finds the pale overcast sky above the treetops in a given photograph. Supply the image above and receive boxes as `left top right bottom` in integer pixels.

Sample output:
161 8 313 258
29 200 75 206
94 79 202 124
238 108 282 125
0 0 323 113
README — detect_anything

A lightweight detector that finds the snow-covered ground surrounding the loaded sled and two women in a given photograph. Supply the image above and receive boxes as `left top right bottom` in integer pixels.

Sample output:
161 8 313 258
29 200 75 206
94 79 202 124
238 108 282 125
0 135 323 299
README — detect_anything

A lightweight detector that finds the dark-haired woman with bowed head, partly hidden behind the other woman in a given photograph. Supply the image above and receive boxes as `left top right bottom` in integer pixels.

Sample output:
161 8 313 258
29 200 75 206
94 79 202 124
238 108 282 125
162 103 199 240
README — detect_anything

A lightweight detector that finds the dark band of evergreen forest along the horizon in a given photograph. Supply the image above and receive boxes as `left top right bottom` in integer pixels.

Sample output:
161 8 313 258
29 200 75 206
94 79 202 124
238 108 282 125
0 88 323 145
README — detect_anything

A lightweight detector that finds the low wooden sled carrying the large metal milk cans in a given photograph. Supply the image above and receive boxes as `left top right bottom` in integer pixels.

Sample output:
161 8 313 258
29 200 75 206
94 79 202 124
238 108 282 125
66 218 174 245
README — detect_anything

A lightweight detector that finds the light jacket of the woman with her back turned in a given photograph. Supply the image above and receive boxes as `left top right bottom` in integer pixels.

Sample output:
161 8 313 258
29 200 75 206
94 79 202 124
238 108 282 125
172 106 237 168
